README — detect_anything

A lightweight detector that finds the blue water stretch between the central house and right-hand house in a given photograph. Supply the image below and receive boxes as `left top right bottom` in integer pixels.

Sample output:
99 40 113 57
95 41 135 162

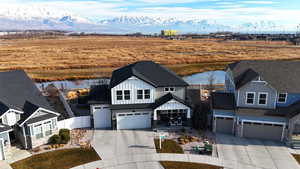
183 71 225 85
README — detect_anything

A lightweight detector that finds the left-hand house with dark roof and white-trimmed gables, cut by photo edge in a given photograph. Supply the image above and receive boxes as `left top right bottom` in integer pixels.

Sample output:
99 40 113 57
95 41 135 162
0 70 59 160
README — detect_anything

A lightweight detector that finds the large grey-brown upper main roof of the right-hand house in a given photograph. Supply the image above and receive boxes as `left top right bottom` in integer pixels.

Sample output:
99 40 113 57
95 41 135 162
228 60 300 93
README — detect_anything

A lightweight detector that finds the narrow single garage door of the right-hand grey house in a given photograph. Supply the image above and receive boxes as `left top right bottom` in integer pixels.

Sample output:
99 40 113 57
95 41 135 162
215 117 234 134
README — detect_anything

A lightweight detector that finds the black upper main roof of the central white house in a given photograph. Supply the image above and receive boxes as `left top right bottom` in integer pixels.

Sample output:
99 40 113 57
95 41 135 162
110 61 188 88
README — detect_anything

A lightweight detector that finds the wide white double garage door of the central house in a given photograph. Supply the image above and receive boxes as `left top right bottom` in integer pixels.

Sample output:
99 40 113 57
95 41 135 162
117 112 151 130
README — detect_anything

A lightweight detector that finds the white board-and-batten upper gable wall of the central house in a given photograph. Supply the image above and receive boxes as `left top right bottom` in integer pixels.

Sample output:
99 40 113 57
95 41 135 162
111 76 155 104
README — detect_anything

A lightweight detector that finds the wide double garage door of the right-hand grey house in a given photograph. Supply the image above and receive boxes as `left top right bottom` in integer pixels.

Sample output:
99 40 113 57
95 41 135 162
243 122 283 141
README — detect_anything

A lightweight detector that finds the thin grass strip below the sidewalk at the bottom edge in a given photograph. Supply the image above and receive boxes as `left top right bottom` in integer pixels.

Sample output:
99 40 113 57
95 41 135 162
160 161 223 169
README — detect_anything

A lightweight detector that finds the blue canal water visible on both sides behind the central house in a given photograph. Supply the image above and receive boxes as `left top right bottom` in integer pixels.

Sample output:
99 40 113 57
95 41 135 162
36 71 225 90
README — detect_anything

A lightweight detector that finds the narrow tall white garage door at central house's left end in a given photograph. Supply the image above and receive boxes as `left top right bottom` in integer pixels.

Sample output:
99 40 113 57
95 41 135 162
93 106 111 128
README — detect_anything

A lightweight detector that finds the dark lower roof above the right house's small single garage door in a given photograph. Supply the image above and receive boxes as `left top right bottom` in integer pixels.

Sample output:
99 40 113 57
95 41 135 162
211 92 235 110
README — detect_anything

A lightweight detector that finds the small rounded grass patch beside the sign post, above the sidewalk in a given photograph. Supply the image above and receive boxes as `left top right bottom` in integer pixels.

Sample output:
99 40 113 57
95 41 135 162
154 139 183 154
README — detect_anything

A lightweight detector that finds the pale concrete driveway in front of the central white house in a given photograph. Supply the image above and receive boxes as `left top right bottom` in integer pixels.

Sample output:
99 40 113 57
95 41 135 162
92 130 156 160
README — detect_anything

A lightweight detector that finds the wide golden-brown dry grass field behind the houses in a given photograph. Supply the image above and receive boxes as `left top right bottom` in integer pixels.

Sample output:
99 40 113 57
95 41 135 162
0 36 300 81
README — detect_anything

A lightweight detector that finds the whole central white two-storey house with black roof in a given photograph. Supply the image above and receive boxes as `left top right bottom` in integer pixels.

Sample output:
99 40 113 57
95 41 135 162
90 61 192 129
